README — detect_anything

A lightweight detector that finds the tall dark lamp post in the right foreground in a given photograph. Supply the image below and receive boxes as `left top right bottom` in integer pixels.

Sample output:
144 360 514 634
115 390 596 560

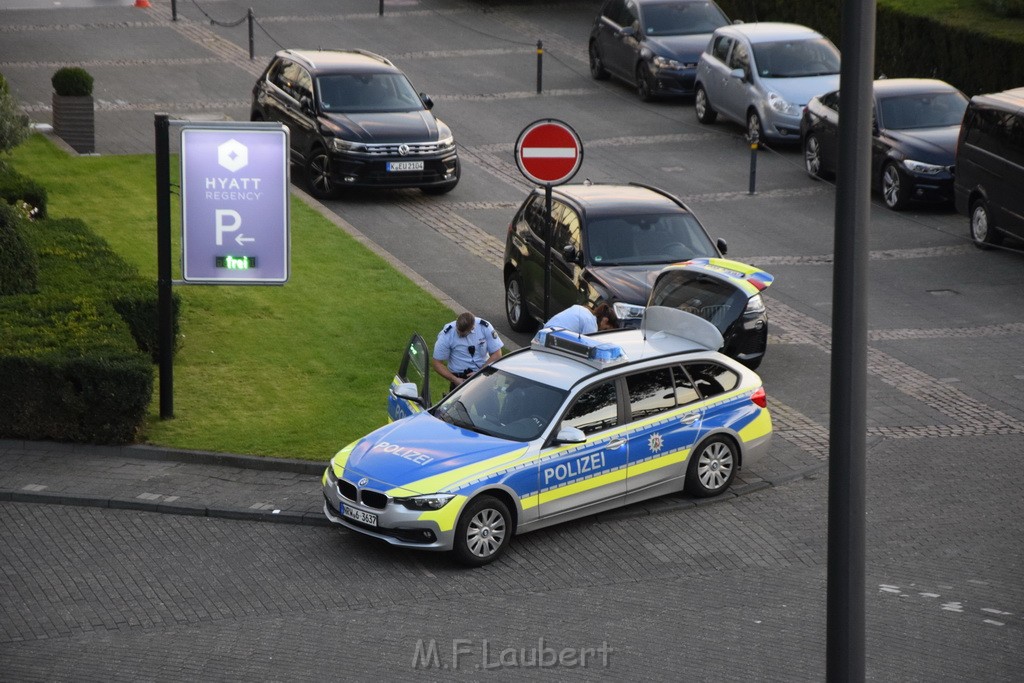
825 0 876 683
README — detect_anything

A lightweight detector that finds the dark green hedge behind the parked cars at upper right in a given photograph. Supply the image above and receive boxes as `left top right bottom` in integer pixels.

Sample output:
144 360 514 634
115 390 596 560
719 0 1024 96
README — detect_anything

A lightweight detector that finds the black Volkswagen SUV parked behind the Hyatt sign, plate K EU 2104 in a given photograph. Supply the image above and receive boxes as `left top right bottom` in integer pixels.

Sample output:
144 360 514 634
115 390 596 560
250 50 461 199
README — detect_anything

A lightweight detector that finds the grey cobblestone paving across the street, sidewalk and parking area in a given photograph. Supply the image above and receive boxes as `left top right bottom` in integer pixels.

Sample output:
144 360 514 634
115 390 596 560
0 0 1024 682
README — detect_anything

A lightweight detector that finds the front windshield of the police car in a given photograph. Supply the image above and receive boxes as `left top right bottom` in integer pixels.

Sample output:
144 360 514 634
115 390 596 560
433 367 567 441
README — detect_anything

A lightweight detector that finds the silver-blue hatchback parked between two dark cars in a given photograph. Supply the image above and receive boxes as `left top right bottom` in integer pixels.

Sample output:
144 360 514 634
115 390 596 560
694 22 840 142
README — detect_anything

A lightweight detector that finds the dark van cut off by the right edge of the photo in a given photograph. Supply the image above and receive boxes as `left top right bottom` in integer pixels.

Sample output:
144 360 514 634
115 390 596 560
953 88 1024 249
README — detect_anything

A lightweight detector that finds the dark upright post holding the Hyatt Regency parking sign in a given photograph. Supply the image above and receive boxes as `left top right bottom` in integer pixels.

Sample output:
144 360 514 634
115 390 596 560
153 114 174 420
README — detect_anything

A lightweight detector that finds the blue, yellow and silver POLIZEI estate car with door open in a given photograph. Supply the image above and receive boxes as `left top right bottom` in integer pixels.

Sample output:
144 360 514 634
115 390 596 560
323 306 772 565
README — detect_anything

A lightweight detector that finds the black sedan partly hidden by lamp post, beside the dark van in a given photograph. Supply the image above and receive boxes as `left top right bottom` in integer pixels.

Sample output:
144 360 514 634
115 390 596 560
800 78 968 211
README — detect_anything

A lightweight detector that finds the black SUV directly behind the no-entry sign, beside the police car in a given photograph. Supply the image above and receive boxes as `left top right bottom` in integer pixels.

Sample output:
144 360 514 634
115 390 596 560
504 182 726 332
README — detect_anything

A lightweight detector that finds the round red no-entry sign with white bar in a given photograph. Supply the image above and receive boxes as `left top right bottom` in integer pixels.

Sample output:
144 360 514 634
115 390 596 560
515 119 583 185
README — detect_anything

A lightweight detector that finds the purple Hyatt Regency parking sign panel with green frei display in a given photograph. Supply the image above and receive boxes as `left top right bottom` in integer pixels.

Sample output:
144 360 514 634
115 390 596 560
181 123 290 285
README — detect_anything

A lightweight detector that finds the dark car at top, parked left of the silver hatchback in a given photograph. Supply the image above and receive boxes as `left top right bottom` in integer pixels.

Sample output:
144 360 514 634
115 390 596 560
590 0 729 101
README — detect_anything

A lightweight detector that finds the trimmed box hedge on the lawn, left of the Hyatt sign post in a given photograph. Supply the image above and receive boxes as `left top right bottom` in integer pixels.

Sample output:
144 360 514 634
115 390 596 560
0 219 180 443
